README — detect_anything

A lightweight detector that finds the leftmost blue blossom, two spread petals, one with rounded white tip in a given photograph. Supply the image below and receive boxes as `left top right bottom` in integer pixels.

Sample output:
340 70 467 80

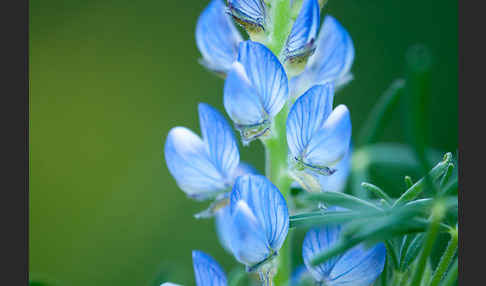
165 103 240 200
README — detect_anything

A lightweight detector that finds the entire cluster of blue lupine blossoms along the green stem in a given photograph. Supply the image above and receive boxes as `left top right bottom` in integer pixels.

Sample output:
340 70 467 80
164 0 385 286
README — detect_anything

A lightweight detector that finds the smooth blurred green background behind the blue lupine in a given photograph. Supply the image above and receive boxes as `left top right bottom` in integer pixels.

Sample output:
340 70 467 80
29 0 458 286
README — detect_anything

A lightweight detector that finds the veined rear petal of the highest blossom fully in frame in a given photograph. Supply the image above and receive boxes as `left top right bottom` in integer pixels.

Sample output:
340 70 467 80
238 41 288 118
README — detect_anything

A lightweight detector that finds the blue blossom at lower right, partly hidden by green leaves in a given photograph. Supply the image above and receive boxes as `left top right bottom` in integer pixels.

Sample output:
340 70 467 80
302 225 386 286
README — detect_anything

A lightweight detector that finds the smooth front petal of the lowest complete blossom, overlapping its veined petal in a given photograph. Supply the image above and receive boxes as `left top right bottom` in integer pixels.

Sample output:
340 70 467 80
229 201 271 266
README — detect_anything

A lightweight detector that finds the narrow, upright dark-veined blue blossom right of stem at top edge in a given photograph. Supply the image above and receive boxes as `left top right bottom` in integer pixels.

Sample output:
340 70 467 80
283 0 320 75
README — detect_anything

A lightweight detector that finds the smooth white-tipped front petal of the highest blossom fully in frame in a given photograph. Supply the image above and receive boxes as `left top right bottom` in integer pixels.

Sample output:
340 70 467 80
223 62 268 125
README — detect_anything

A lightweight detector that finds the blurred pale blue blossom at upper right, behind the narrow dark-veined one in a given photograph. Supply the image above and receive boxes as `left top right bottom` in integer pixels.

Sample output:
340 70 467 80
290 15 354 97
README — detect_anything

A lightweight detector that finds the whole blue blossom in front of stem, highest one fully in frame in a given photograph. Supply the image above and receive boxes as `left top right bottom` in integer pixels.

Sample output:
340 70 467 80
224 41 288 144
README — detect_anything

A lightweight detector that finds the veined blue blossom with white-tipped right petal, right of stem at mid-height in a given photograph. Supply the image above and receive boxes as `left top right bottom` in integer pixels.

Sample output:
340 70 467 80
287 84 351 191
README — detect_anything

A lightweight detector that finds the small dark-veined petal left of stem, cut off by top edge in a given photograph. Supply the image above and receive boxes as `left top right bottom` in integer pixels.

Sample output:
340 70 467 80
228 0 266 28
